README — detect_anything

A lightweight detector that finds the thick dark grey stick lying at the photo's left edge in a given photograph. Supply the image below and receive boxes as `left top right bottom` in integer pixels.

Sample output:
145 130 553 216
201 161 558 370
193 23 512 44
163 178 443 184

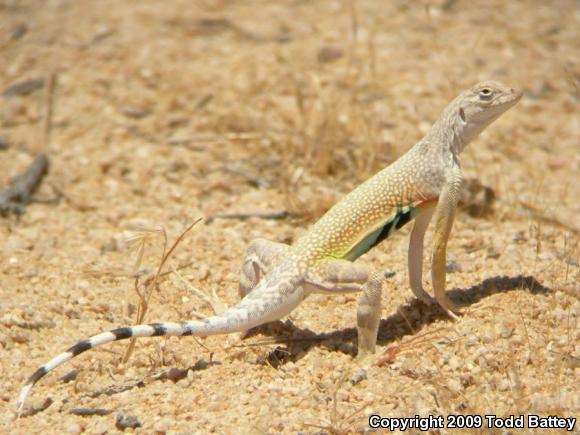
0 154 49 216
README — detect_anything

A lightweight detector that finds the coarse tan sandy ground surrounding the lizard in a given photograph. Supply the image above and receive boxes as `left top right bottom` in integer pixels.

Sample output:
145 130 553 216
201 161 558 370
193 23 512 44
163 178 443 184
0 0 580 434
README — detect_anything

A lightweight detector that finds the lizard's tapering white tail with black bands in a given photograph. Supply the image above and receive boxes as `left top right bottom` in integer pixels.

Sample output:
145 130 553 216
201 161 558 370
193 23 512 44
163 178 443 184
16 316 240 415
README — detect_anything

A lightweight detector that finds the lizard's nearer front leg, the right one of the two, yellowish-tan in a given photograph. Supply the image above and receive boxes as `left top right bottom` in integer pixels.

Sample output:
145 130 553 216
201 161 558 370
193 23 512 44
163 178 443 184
431 168 463 320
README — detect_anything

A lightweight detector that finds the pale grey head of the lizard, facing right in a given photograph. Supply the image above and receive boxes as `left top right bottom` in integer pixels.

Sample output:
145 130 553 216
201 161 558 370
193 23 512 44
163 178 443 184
453 80 522 141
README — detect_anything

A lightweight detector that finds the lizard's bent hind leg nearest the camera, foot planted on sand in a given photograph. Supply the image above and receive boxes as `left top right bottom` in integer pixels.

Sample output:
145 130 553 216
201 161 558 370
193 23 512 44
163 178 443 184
305 260 384 362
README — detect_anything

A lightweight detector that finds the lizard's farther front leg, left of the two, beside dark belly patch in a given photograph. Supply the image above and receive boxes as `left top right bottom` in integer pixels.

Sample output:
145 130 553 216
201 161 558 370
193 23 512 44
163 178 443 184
408 201 437 304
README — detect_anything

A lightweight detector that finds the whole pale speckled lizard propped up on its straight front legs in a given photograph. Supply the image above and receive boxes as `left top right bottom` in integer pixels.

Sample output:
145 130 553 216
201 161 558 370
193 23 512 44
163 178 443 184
16 81 522 414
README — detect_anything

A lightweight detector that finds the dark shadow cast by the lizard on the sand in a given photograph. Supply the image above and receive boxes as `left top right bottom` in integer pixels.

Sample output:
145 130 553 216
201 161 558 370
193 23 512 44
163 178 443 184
251 275 552 367
